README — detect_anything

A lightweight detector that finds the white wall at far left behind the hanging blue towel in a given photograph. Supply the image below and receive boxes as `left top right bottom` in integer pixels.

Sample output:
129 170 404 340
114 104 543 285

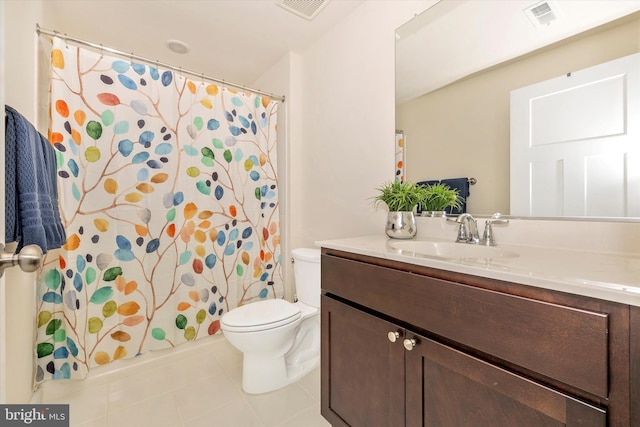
0 0 46 403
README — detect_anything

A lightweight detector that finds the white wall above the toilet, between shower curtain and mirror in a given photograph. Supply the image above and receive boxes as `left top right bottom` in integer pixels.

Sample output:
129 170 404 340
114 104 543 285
290 1 434 247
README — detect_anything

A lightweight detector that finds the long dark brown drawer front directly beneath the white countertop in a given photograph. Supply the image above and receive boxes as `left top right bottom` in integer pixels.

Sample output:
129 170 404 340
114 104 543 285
321 255 609 398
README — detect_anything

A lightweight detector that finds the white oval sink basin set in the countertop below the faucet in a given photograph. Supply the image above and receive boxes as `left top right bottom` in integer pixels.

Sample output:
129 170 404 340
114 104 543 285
389 240 520 261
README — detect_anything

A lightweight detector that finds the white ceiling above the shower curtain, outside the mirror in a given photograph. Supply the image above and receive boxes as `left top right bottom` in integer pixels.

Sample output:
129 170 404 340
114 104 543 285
42 0 365 89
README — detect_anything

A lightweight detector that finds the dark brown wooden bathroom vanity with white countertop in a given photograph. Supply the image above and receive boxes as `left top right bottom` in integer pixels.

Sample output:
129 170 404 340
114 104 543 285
320 237 640 427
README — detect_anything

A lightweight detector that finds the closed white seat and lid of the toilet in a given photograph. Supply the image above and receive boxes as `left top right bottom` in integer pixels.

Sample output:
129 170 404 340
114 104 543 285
220 299 302 332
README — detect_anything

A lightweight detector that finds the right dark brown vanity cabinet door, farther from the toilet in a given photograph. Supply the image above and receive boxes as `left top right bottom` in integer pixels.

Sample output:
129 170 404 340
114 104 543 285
406 334 607 427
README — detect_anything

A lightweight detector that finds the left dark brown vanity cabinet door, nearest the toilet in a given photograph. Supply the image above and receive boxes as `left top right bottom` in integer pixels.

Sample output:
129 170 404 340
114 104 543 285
321 296 405 427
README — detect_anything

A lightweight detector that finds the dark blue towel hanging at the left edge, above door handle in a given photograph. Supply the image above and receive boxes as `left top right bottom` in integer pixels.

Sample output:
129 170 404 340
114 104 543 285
5 105 66 253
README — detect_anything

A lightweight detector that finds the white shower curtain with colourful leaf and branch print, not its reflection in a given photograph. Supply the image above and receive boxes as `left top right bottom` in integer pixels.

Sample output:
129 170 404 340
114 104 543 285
35 37 283 382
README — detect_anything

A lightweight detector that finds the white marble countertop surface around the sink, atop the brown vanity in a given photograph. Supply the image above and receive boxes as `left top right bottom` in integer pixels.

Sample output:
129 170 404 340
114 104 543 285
316 235 640 307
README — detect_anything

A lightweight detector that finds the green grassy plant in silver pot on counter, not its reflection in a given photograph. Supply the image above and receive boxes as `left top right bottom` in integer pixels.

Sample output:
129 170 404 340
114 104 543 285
373 181 427 239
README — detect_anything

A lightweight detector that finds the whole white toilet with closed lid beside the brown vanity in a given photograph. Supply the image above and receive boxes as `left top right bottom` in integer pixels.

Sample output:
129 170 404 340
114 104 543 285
220 248 320 394
